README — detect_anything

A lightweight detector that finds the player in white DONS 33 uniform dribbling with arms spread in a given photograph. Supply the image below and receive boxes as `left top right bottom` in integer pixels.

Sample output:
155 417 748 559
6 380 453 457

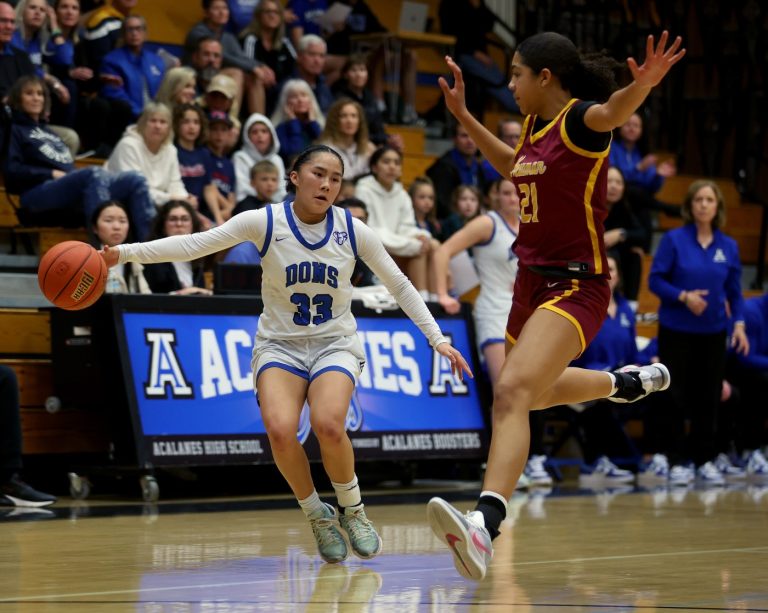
102 145 472 563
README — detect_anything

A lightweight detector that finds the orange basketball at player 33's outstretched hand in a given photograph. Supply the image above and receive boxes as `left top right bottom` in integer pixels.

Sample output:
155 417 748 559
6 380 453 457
37 241 107 311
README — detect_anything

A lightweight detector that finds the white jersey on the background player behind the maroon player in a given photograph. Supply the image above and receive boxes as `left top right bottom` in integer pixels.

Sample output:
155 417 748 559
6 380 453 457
472 211 517 313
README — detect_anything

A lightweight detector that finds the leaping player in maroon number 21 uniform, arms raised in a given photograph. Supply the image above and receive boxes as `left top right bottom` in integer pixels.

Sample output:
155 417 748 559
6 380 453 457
427 32 685 580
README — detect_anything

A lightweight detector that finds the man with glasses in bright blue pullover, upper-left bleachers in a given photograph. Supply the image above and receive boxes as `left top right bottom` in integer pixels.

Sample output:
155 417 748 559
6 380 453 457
99 15 165 120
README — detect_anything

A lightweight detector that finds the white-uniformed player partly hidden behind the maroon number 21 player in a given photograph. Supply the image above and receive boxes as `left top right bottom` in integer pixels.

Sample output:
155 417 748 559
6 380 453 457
434 179 520 385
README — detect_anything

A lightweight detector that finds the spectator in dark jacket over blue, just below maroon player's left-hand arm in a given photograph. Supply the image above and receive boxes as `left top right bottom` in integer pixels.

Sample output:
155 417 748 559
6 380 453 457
427 124 487 220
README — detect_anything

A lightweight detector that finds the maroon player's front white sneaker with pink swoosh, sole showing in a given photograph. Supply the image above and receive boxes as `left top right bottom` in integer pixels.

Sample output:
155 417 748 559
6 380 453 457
427 497 493 581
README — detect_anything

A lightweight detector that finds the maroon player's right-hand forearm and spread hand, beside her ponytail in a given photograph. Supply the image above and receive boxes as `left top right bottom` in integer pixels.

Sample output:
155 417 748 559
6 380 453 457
584 30 685 132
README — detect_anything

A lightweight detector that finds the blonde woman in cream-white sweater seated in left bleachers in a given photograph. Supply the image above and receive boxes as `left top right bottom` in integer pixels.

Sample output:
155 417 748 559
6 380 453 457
105 102 197 209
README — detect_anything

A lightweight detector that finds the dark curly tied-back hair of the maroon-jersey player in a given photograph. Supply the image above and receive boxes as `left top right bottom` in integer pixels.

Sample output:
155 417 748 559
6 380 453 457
517 32 620 102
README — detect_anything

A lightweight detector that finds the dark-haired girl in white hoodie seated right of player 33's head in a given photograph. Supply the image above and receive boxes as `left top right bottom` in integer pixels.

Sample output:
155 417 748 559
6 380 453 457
355 146 440 299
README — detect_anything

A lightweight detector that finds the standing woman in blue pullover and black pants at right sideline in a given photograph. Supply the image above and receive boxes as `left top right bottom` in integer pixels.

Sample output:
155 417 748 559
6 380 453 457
649 180 749 485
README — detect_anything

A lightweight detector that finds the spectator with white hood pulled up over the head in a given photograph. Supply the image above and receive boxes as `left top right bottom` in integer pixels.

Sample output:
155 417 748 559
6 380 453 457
232 113 285 202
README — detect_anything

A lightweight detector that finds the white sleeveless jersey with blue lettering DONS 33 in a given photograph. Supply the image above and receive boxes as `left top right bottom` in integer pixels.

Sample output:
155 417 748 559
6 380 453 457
258 202 357 339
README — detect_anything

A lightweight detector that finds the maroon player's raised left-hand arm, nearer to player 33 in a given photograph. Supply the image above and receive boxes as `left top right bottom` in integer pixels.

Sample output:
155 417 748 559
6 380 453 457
437 55 515 176
